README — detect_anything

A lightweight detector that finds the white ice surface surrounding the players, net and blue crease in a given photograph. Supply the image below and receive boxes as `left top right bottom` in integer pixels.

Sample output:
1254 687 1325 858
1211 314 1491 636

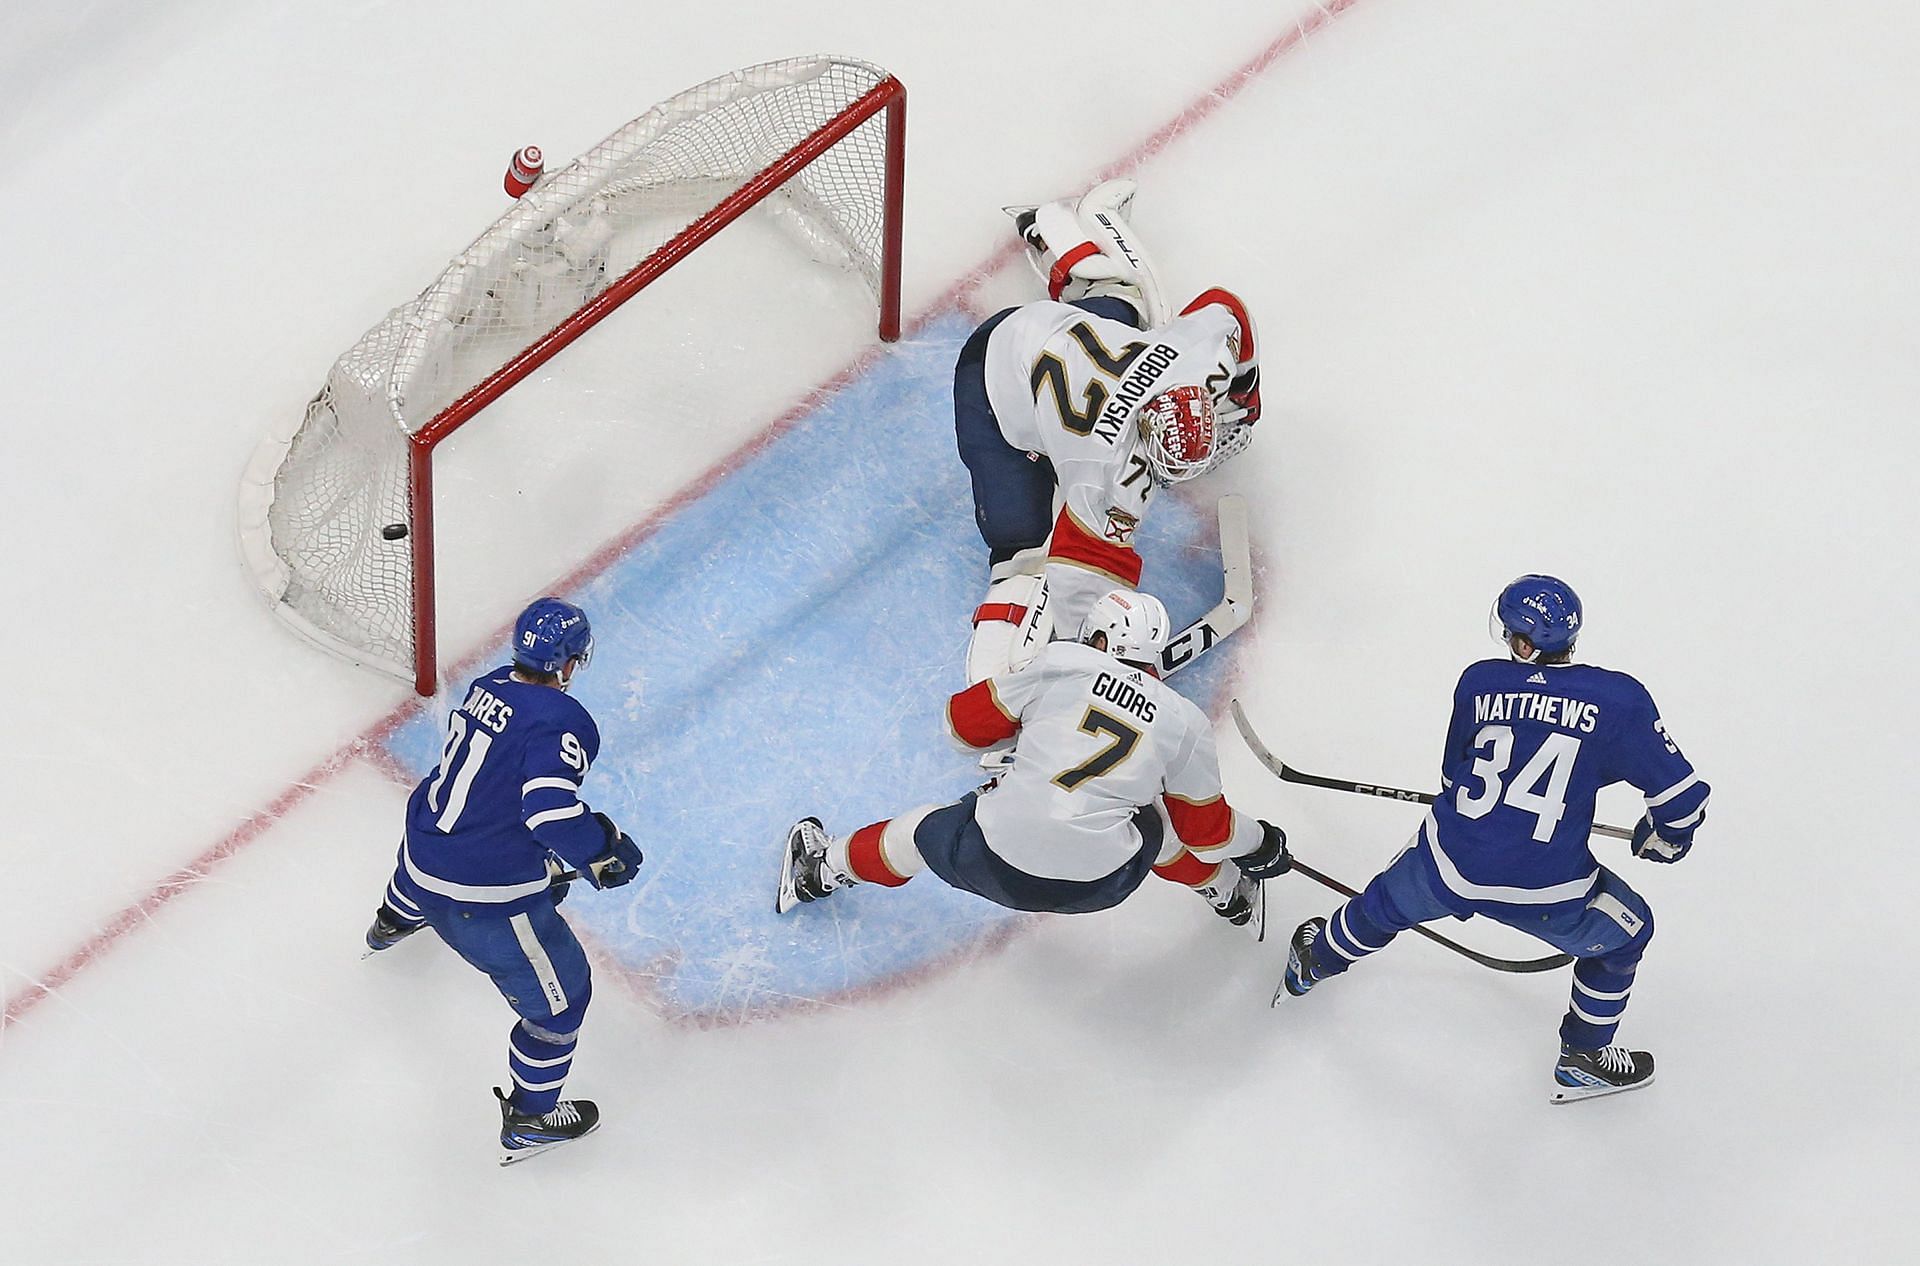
0 0 1920 1264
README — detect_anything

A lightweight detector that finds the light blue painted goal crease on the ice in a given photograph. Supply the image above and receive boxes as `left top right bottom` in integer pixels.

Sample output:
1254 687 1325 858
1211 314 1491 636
388 317 1231 1020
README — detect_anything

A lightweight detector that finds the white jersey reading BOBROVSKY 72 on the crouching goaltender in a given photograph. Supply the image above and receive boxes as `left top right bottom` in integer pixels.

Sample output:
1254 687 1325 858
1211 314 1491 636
987 302 1240 636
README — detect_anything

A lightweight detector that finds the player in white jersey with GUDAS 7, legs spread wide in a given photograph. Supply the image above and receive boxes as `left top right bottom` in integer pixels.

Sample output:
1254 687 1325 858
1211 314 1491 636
776 590 1292 930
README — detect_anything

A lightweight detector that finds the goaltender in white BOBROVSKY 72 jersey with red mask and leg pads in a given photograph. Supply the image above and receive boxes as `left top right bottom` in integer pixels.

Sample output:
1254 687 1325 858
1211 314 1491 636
954 181 1260 682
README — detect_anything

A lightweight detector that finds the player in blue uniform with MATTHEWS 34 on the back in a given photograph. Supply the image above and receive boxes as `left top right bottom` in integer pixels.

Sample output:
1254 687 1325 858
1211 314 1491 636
1286 576 1709 1103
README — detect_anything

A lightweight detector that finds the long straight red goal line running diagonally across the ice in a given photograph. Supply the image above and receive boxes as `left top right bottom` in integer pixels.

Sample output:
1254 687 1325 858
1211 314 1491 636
0 0 1382 1032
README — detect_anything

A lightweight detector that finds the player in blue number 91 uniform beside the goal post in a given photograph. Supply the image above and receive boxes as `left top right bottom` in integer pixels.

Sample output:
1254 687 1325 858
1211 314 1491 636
367 597 641 1164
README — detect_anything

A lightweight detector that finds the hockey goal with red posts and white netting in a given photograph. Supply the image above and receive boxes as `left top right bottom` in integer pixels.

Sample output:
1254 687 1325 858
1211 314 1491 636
240 56 906 695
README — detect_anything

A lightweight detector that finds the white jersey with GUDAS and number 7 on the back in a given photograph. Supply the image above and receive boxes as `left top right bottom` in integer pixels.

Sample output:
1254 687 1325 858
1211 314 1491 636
947 642 1261 880
